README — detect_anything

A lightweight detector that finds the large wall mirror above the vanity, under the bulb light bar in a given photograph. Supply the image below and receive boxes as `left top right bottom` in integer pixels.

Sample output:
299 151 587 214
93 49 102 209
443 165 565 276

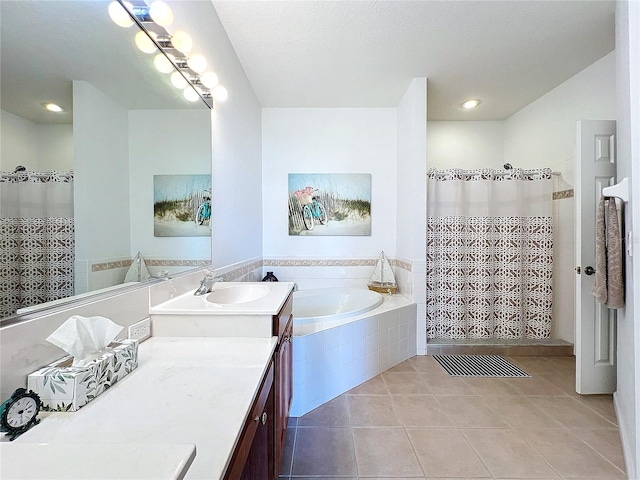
0 0 211 319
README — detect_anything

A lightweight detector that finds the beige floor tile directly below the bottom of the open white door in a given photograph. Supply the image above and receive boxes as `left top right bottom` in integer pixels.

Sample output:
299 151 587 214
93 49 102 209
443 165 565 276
529 397 616 429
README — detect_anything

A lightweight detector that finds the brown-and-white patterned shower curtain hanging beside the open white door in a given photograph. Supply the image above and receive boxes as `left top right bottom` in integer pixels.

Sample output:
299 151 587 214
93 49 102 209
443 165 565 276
426 164 554 345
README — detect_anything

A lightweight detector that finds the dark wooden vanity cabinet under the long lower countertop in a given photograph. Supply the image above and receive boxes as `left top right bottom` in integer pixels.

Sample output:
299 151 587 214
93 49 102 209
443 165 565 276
224 362 275 480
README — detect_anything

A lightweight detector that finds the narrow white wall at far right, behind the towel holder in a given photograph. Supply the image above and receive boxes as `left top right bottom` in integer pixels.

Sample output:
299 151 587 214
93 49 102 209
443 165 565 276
614 1 640 479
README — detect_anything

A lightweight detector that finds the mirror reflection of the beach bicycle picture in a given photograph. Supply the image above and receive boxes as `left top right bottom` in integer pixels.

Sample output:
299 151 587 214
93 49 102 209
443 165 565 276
153 174 211 237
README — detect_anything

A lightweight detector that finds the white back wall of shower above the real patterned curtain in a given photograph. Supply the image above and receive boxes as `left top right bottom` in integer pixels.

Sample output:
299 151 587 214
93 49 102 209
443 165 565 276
427 121 504 169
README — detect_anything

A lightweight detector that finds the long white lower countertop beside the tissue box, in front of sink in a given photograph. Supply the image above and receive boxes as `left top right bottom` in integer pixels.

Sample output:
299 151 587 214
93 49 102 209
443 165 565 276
0 337 277 479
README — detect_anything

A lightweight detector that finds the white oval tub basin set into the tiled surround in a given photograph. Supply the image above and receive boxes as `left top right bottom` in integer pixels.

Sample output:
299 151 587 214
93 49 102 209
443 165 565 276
293 288 383 325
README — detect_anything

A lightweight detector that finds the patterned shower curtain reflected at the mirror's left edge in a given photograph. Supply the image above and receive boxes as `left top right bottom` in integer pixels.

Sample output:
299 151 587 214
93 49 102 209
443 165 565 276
0 166 75 318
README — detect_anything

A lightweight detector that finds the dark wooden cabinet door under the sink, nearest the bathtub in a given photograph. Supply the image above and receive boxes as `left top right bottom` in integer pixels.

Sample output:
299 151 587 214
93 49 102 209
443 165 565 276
274 315 293 477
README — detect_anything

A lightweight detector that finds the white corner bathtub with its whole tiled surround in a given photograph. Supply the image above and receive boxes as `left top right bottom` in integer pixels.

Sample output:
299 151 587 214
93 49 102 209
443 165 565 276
291 288 417 417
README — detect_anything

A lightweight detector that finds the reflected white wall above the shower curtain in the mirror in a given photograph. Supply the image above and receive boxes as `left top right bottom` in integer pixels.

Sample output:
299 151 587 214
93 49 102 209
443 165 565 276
0 110 73 172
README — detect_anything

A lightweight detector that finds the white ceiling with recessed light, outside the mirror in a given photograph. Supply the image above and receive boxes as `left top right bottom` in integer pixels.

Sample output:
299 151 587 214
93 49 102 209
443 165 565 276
213 0 615 120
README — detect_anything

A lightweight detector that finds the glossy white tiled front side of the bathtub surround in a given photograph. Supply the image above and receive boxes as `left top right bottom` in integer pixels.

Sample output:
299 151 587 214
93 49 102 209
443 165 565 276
291 303 416 417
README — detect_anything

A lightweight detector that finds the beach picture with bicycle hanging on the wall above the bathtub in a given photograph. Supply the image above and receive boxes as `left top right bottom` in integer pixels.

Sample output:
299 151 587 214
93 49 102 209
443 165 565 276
289 173 371 236
